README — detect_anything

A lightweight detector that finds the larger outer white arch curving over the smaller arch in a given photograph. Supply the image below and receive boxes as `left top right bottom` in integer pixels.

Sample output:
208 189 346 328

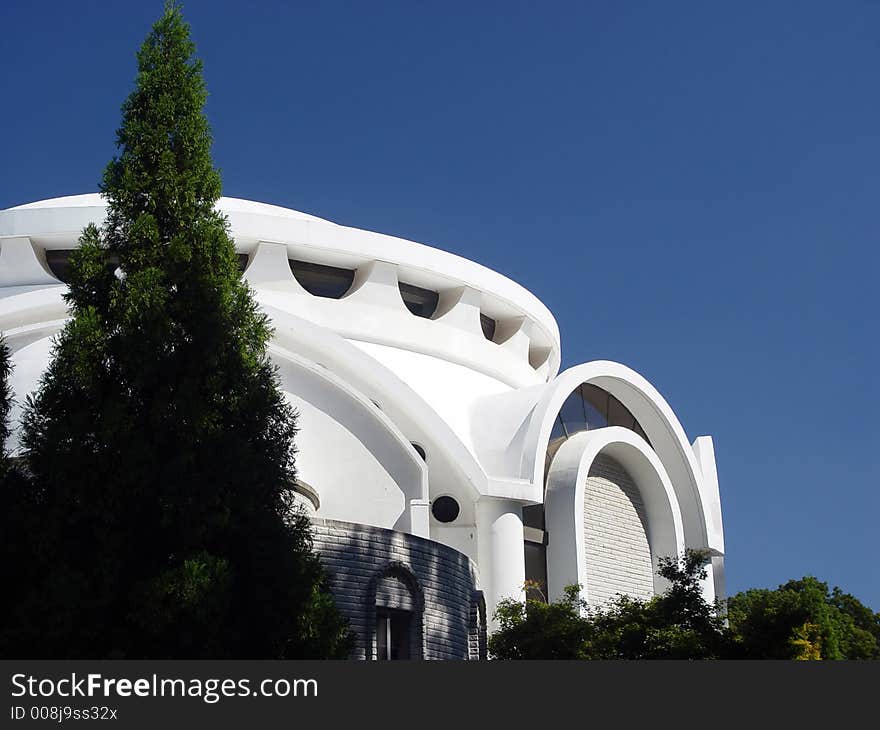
521 360 724 552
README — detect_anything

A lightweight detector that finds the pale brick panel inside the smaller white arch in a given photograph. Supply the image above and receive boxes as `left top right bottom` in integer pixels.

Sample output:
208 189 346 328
584 455 654 604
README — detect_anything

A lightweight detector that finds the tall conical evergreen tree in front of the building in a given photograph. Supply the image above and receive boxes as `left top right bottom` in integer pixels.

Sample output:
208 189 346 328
5 4 348 658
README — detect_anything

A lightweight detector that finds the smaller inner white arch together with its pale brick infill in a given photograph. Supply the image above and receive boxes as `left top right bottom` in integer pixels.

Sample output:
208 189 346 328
545 426 685 605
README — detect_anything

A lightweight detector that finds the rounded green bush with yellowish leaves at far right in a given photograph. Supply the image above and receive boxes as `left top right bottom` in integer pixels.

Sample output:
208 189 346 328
728 576 880 659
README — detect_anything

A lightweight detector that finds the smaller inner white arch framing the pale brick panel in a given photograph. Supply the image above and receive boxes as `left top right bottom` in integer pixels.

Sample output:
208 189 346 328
544 426 685 600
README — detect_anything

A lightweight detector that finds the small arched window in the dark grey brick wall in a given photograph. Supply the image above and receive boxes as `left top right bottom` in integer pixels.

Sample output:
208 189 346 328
372 564 424 661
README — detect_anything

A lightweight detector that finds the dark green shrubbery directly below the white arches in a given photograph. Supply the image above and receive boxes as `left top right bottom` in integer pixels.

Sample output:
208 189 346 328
489 551 730 659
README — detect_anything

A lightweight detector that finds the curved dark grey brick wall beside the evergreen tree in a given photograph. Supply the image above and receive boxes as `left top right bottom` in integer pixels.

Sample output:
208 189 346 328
312 518 485 659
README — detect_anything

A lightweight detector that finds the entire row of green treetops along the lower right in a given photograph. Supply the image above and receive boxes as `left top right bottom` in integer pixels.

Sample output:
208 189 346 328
489 551 880 660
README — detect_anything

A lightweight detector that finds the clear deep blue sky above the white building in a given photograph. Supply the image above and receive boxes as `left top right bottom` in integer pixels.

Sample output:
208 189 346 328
0 0 880 609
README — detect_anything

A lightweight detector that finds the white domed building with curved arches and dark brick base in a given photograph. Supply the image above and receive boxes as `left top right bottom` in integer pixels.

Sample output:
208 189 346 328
0 194 724 659
